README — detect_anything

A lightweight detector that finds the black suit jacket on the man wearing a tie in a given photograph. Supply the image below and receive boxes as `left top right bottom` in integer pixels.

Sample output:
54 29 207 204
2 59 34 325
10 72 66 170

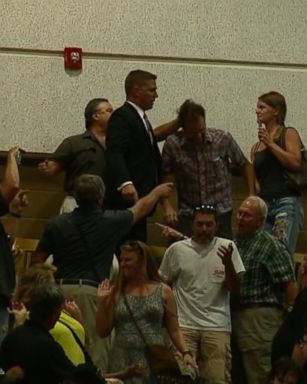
106 102 161 208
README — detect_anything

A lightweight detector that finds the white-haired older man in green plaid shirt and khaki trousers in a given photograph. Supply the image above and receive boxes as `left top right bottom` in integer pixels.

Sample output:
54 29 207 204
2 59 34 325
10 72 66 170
232 196 296 384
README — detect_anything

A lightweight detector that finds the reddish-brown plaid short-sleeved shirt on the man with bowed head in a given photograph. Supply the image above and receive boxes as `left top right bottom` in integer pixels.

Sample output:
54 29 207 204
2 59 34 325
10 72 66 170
162 128 246 215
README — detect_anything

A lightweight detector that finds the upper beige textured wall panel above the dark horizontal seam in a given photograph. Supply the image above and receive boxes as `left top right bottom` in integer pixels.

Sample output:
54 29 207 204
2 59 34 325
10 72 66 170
1 0 307 63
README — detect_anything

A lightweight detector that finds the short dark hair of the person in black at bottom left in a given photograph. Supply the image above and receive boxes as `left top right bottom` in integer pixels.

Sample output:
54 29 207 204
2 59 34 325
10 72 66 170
29 284 64 322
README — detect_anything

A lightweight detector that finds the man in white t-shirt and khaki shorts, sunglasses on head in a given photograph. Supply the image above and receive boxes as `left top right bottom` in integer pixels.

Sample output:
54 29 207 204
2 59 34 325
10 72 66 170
160 205 245 384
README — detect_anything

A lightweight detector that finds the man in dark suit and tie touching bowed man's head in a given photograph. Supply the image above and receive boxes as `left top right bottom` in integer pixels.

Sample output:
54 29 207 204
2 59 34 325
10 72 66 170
106 70 178 241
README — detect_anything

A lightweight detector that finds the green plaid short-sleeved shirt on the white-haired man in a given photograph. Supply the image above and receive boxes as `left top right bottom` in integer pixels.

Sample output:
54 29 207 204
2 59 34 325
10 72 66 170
237 229 295 304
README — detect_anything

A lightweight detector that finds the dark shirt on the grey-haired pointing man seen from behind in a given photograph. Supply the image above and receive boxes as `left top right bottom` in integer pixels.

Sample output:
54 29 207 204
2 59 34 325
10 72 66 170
37 206 133 282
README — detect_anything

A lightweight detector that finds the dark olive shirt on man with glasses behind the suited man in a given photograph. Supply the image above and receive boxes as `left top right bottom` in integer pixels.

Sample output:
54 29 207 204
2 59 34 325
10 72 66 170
50 131 106 193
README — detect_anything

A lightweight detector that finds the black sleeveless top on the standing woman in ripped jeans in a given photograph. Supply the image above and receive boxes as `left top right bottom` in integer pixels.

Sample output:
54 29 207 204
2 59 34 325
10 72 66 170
254 138 299 200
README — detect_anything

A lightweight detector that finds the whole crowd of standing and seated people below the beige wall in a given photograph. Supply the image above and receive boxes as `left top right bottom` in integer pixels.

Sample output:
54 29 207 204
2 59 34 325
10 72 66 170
0 70 307 384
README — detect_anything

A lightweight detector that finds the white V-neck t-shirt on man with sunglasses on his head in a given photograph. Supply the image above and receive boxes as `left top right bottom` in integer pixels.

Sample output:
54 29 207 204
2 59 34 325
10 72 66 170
160 237 245 332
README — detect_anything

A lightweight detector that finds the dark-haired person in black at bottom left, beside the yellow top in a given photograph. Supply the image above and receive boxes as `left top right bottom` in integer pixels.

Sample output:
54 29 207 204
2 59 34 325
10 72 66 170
0 284 105 384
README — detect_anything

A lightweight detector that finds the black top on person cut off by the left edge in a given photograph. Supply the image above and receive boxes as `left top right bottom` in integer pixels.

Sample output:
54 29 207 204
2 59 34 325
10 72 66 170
0 194 15 306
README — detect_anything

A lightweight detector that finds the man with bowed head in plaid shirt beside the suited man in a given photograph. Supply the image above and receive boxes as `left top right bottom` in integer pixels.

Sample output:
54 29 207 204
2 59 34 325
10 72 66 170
162 100 253 238
